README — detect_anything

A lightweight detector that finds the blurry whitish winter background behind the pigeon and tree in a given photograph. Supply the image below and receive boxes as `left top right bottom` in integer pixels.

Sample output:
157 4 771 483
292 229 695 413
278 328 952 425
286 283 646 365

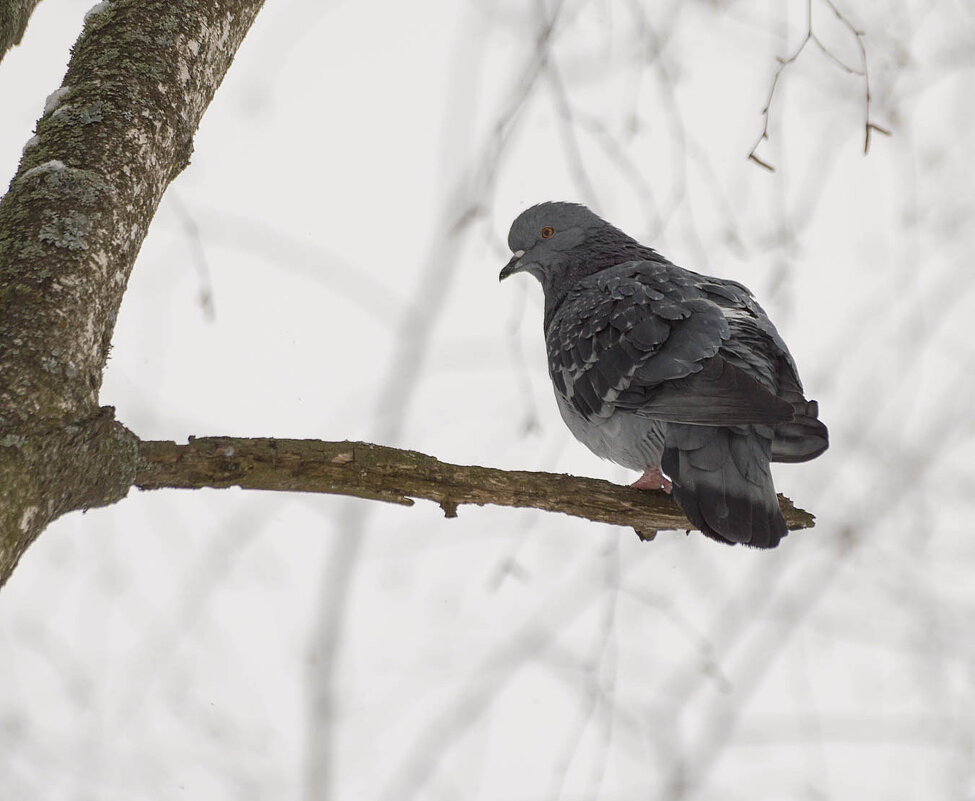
0 0 975 801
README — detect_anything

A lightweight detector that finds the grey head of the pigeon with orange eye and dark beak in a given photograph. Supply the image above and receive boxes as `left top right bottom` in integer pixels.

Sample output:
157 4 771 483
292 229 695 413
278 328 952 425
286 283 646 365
498 202 612 286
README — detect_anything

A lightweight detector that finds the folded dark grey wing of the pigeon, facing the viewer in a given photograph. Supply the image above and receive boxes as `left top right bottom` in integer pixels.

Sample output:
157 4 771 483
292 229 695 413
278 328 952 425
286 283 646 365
546 261 793 426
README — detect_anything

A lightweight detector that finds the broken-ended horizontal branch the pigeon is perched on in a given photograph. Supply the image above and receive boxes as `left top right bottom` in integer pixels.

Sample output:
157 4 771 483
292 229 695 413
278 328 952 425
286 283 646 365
135 437 814 539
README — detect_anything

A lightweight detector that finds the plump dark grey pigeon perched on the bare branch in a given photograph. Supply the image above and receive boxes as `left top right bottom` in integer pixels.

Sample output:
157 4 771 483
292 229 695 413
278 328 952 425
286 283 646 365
499 202 829 548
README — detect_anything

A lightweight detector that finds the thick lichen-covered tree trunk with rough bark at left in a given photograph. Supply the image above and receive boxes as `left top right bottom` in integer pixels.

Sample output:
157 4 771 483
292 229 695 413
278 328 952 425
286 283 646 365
0 0 263 585
